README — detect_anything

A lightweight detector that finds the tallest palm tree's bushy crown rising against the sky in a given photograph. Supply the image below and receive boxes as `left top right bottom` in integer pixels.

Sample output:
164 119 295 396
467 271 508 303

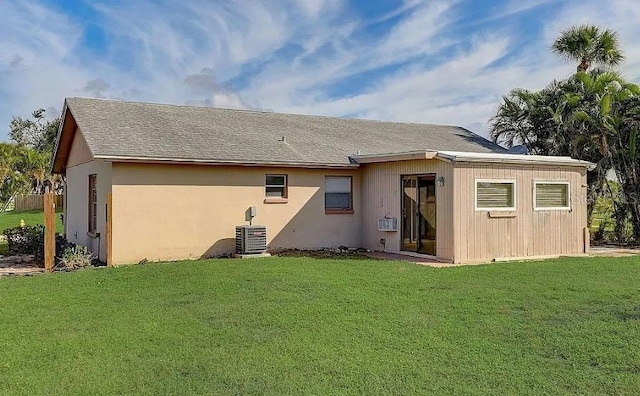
551 25 624 72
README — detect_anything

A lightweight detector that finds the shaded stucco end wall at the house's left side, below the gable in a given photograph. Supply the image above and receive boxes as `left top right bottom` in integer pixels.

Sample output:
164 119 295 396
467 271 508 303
64 161 111 261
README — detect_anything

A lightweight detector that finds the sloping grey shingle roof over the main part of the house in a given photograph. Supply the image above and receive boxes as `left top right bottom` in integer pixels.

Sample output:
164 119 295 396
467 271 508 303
66 98 506 166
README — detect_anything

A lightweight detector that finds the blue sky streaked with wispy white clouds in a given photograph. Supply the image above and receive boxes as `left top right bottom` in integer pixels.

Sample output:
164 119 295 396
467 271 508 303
0 0 640 140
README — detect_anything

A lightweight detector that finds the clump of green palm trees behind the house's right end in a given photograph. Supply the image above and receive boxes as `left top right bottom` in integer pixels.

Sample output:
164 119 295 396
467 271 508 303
491 26 640 243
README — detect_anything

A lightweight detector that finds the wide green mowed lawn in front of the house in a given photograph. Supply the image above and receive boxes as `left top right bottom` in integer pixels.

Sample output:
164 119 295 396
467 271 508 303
0 257 640 395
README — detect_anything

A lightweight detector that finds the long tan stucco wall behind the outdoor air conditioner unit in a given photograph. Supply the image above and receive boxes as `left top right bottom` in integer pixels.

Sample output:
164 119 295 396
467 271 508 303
113 163 362 264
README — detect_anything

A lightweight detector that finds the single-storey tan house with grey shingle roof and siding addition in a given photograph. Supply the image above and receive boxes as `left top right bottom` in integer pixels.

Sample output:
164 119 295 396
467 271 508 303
52 98 590 264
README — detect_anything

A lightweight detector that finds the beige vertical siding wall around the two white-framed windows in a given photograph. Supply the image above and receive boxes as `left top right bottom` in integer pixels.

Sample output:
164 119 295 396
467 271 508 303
454 164 587 262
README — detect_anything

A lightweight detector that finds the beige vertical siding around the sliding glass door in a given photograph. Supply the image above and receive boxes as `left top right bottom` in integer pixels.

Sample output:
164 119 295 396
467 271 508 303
362 160 454 261
